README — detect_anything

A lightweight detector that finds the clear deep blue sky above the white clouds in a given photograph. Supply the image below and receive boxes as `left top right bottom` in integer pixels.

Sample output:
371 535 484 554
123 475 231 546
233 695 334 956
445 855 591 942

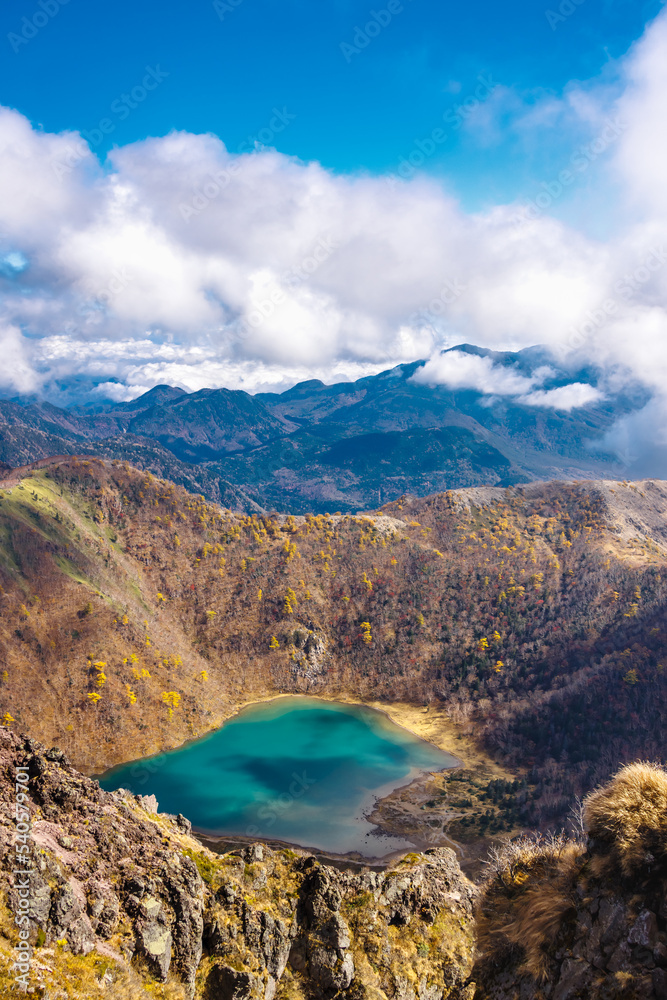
0 0 661 209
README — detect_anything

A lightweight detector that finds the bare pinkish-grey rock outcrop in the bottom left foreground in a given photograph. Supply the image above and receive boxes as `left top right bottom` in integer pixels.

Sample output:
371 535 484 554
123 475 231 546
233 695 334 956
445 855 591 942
0 730 205 995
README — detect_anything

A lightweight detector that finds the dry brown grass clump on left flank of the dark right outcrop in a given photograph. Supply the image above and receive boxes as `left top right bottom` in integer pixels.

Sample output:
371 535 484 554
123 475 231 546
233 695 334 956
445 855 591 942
477 835 584 980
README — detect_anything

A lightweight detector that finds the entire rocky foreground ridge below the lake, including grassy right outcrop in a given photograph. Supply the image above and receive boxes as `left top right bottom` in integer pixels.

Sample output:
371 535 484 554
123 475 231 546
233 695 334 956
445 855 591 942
0 727 667 1000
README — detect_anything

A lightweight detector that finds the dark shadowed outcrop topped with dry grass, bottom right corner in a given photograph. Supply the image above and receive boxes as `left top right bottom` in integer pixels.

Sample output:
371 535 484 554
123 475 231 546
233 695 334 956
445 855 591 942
474 764 667 1000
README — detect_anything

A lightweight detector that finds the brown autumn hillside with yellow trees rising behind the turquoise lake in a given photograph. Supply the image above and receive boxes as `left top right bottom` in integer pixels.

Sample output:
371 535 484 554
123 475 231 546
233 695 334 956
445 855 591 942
0 459 667 839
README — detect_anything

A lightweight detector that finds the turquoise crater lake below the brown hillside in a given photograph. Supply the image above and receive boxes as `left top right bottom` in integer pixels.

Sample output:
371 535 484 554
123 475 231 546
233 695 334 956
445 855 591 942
100 697 459 857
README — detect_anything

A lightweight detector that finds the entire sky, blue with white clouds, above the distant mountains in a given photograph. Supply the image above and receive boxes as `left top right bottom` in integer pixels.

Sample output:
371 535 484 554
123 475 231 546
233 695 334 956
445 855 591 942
0 0 667 470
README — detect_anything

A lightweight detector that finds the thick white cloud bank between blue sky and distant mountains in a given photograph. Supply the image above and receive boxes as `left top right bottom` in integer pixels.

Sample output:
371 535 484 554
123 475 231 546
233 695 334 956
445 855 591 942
0 14 667 450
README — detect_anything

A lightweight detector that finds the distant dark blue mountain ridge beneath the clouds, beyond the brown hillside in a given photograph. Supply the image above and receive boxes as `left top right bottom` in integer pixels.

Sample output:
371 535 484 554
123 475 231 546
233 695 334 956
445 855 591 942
0 344 647 513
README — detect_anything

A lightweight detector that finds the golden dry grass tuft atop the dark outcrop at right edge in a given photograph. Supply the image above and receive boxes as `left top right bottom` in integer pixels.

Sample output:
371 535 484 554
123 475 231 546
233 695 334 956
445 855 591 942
584 762 667 876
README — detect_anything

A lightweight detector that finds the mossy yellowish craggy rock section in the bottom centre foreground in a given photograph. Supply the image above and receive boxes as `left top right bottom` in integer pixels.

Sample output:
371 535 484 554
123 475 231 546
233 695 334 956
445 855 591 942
203 844 475 1000
